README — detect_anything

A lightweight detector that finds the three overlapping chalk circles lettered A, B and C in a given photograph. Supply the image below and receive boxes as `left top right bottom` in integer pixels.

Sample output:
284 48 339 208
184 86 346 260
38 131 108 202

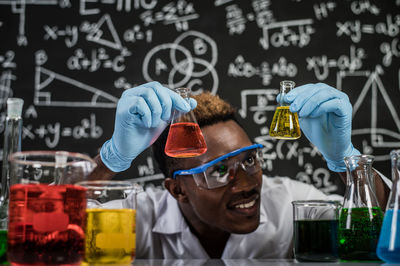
142 31 219 94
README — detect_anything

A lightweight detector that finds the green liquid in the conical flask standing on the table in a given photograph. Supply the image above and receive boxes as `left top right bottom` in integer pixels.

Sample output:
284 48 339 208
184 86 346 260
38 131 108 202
339 207 383 260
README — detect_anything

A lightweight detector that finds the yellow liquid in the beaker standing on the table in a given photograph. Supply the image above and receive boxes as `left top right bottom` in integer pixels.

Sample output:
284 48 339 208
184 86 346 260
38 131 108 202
85 209 136 264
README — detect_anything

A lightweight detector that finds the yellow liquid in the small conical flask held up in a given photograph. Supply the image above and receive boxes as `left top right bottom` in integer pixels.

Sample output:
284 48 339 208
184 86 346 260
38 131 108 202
269 106 301 139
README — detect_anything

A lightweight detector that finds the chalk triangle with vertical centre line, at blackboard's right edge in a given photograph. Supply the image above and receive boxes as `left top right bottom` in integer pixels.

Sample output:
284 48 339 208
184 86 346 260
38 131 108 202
340 71 400 148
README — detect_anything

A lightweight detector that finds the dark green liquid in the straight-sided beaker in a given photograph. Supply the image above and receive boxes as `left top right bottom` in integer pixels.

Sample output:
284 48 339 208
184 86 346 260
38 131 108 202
294 220 339 261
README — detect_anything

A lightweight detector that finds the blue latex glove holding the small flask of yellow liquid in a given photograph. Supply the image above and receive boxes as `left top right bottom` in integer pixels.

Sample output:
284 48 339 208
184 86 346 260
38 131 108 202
278 83 360 172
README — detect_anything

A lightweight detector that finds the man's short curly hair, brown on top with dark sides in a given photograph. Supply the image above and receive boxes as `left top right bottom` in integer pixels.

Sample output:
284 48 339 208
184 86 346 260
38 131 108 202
152 92 238 177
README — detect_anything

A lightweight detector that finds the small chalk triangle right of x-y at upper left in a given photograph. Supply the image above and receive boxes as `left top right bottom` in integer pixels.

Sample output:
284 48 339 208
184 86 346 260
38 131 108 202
86 14 122 50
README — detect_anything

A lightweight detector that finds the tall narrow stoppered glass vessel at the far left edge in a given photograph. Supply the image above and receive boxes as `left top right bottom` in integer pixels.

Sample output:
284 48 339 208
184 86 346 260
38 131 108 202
0 98 24 264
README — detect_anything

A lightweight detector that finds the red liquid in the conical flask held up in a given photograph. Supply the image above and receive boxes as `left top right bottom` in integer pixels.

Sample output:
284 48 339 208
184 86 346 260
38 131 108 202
165 123 207 158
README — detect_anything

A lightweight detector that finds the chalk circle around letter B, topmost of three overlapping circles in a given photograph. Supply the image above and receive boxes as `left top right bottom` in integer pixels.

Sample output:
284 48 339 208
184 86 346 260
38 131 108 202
170 31 218 77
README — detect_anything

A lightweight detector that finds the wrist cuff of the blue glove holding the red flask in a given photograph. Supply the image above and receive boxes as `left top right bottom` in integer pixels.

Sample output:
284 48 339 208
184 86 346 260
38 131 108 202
100 139 133 173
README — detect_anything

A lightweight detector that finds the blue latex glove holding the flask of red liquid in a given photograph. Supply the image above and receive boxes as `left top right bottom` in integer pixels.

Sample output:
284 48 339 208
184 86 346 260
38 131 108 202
100 82 197 172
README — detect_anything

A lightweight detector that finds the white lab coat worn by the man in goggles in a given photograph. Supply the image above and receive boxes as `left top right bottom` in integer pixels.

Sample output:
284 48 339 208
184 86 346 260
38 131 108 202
136 176 343 259
